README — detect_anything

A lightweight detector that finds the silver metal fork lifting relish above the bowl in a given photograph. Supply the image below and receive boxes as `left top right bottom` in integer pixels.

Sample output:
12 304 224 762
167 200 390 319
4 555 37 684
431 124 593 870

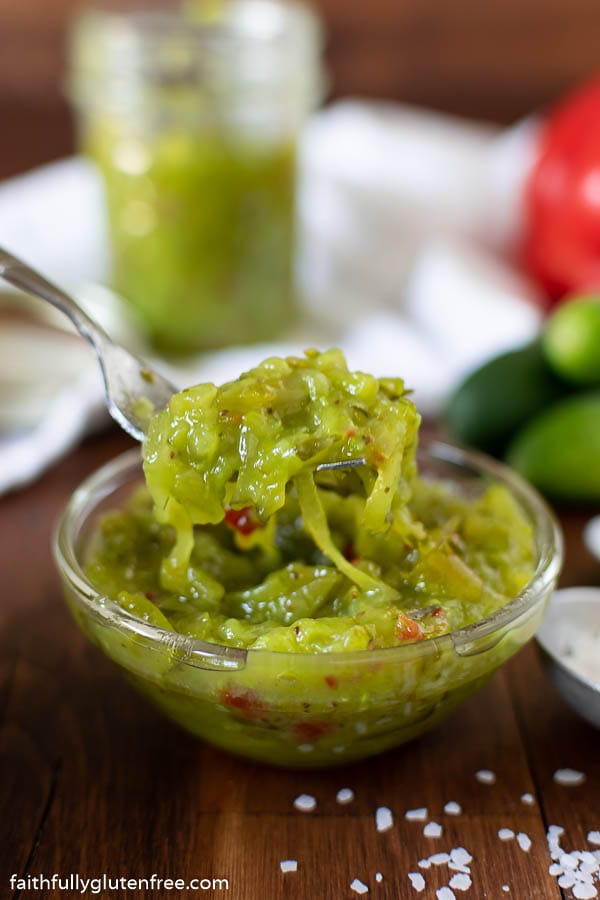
0 247 365 472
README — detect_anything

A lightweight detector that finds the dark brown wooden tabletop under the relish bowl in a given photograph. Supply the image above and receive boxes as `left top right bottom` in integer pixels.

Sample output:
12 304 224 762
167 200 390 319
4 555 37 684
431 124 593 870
0 432 600 900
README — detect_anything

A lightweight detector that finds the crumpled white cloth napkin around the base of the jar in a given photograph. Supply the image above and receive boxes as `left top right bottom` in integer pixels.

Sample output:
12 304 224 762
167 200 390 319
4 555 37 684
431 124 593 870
0 101 541 494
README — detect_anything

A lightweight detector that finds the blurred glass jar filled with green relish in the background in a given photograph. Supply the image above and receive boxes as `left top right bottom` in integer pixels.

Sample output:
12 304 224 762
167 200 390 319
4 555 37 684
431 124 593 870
69 0 322 353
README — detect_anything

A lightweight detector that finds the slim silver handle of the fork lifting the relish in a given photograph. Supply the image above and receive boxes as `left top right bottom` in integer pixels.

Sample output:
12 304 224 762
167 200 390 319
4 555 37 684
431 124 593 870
0 247 110 352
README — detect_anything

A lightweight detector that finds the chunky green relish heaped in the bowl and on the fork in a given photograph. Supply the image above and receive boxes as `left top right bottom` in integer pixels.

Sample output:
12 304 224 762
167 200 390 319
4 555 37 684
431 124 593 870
87 350 535 654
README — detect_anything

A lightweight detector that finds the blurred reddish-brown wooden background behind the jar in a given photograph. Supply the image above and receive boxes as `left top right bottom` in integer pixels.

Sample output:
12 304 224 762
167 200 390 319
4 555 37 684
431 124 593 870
0 0 600 178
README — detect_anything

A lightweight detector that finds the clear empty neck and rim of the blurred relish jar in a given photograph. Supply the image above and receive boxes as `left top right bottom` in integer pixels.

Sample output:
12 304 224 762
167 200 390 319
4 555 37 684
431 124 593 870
67 0 325 114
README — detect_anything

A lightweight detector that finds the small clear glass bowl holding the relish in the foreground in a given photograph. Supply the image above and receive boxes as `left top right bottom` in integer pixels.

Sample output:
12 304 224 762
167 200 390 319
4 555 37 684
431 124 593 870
54 443 562 767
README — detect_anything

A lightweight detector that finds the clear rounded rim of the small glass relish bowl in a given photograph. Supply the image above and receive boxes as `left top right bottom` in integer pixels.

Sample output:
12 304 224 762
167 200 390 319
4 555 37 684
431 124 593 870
52 440 563 668
